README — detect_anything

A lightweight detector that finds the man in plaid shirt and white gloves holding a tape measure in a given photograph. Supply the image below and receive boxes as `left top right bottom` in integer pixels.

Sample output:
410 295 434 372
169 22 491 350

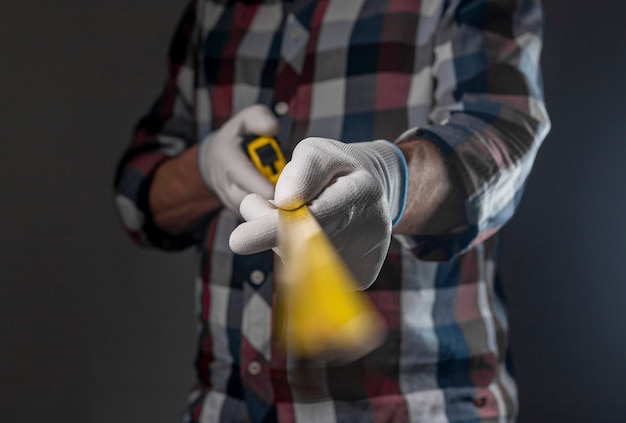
115 0 549 422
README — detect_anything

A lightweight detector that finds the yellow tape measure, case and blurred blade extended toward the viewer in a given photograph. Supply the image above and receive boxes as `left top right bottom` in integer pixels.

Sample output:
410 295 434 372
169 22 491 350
242 136 386 361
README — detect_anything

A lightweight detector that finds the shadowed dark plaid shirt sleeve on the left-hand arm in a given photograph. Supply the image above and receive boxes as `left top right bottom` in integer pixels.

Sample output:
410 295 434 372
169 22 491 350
114 1 197 249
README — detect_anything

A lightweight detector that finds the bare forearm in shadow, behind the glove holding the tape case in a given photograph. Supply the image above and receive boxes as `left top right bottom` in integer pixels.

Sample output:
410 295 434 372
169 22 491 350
149 146 222 235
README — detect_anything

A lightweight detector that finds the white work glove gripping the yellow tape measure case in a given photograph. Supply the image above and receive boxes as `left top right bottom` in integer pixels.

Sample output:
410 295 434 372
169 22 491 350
198 104 278 215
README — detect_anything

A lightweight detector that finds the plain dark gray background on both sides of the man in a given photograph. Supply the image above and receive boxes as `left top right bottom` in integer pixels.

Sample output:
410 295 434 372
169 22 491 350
0 0 626 423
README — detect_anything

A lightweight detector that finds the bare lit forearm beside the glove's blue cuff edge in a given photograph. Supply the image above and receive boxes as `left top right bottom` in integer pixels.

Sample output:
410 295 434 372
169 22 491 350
394 139 465 235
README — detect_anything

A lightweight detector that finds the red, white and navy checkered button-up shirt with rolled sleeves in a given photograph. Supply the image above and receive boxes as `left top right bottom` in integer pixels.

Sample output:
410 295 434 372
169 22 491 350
115 0 550 423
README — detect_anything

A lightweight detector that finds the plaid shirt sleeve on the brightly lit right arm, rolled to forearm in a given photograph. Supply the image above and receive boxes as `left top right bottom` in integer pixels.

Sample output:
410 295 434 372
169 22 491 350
398 0 550 260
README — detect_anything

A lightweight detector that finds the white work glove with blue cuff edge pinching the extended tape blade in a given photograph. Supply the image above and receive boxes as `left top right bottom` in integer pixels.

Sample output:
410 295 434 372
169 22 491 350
230 138 408 289
